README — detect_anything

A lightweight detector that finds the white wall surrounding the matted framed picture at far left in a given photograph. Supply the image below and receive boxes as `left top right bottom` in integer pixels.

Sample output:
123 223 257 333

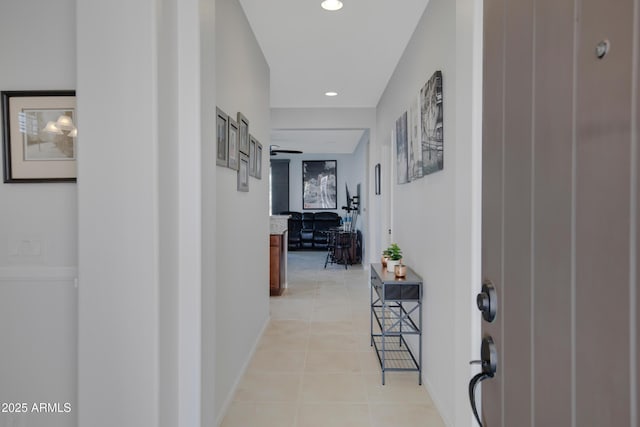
0 0 78 427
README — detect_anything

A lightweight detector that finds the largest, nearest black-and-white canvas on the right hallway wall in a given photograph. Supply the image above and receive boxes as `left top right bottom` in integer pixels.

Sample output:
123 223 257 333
420 71 444 175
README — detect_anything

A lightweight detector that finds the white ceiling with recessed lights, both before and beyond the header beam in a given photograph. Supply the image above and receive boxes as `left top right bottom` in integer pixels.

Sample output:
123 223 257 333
240 0 429 153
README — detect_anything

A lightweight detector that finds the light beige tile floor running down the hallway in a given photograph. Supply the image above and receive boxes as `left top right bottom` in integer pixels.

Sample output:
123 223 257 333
222 252 444 427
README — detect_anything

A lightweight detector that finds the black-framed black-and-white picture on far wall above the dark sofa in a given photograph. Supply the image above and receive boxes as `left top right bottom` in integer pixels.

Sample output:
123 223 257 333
302 160 338 210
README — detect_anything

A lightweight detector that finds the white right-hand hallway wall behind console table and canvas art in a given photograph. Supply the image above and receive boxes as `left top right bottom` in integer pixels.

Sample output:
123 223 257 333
371 0 480 426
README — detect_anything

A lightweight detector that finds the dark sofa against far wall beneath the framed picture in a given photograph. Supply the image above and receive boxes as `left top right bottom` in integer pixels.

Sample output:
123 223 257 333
280 211 341 250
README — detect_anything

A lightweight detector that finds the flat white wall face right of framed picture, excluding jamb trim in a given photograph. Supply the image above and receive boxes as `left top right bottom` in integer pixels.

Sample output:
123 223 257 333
77 0 159 427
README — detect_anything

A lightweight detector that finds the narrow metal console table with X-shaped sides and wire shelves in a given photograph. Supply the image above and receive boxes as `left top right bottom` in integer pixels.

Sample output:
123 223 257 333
370 264 422 385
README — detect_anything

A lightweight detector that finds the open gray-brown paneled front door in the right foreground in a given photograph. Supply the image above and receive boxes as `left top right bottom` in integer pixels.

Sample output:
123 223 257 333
482 0 640 427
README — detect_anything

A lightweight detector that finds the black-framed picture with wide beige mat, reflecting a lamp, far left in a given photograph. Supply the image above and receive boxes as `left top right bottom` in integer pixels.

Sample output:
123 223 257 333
0 90 77 183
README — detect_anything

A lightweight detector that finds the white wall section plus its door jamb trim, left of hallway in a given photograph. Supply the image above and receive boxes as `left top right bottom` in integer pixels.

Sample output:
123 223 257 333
77 0 208 427
